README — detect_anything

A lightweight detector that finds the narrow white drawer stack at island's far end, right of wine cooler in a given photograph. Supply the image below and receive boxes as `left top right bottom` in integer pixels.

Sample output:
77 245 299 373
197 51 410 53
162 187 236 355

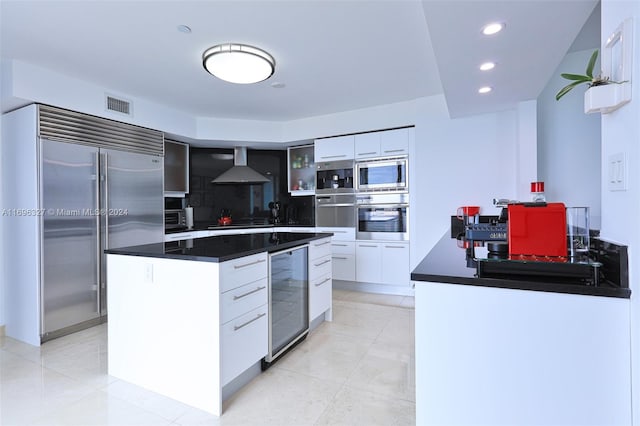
309 238 333 321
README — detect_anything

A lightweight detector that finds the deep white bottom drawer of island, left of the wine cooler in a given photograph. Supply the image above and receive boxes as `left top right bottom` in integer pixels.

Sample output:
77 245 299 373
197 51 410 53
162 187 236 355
220 305 269 386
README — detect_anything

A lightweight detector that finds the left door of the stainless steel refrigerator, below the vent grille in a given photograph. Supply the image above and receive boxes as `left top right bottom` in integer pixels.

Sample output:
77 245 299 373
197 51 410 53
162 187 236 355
41 140 100 335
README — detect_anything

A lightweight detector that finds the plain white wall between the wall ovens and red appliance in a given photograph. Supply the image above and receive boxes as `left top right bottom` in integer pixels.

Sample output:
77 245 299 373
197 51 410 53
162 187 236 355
410 96 519 268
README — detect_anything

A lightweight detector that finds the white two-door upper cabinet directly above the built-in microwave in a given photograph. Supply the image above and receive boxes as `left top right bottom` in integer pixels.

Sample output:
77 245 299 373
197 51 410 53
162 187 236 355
354 129 409 160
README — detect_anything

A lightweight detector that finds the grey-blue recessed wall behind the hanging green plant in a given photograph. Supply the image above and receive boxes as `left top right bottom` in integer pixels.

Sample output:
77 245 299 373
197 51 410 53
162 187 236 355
538 46 601 229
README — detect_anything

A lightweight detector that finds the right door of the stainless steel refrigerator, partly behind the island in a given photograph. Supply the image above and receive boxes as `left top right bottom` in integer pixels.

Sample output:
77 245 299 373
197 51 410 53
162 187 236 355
101 149 164 314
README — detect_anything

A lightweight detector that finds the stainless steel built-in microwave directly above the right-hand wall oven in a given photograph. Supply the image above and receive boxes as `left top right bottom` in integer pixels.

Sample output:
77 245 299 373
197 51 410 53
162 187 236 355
355 156 409 192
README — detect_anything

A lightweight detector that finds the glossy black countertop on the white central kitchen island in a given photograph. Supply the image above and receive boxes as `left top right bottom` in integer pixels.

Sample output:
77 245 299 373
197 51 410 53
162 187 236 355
105 232 333 262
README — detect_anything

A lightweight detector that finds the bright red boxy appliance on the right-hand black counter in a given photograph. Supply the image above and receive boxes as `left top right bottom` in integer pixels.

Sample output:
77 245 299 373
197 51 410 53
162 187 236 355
507 203 567 258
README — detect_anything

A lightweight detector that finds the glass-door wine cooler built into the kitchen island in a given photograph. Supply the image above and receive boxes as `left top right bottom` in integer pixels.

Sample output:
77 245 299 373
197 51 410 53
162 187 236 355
262 245 309 370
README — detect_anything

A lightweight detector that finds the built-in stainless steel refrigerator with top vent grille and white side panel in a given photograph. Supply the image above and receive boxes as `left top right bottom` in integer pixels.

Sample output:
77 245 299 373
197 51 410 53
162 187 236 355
3 105 164 344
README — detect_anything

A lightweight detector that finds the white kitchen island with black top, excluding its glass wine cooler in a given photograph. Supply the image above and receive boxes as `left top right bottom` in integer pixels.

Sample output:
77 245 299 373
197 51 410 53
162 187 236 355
106 232 331 415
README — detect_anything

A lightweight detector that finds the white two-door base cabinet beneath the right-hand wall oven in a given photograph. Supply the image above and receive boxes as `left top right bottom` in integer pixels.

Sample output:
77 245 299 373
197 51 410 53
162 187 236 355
356 241 410 286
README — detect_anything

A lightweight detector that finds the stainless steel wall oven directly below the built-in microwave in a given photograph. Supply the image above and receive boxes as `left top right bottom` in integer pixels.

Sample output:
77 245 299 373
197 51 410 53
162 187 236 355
356 194 409 241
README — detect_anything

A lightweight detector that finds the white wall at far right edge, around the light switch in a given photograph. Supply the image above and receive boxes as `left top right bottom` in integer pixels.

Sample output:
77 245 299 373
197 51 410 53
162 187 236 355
601 0 640 425
